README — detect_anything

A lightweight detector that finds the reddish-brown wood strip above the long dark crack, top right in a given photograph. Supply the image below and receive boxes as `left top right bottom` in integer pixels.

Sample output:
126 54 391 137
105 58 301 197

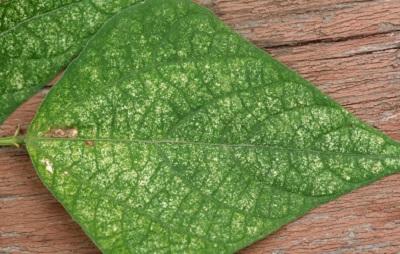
213 0 400 47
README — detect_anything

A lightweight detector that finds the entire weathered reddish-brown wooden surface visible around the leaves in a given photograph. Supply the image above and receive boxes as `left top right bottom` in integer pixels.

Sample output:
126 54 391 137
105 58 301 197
0 0 400 254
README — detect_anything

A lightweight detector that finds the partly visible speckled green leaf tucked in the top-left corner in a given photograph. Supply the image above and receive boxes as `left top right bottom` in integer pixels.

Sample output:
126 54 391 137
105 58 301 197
0 0 144 124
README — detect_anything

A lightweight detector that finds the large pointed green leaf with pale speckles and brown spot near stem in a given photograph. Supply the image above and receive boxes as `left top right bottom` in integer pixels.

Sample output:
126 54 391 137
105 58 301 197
26 0 400 253
